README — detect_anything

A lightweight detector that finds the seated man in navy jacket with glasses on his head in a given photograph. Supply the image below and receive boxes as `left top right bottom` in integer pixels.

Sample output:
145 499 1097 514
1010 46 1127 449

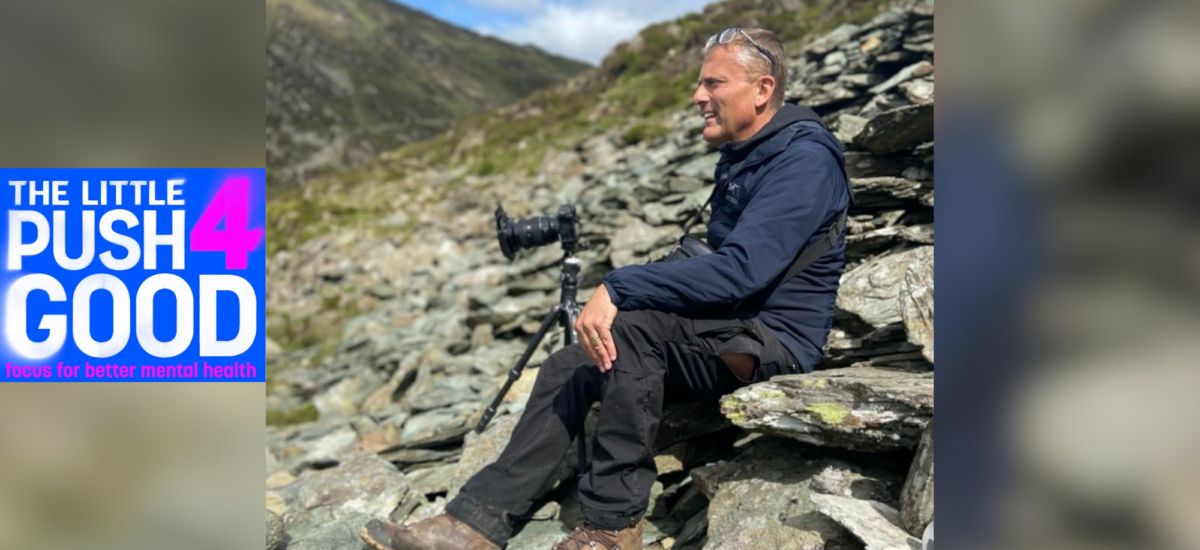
361 28 850 550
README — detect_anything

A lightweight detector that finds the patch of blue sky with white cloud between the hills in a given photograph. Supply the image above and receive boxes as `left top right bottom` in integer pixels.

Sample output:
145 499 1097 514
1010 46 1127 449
392 0 716 65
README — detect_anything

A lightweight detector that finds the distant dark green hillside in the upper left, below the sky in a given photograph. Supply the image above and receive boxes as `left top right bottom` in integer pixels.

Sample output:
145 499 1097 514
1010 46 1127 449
266 0 589 184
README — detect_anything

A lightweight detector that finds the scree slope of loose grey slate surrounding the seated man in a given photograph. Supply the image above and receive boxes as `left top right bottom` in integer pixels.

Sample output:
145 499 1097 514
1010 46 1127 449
266 1 934 550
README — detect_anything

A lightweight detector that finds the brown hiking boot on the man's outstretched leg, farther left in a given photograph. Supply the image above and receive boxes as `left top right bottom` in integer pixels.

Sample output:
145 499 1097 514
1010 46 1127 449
359 514 501 550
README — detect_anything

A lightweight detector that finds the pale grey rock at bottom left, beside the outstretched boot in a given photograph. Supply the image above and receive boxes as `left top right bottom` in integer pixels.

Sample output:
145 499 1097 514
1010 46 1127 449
284 452 424 550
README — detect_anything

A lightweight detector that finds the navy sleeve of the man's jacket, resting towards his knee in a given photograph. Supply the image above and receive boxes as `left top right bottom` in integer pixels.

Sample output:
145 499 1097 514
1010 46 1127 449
604 142 845 311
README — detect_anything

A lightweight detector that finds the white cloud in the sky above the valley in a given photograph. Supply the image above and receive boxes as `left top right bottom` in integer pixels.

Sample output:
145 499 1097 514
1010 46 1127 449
470 0 708 64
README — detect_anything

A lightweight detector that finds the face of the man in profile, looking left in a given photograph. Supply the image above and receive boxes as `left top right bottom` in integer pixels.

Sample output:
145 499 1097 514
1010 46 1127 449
691 47 769 145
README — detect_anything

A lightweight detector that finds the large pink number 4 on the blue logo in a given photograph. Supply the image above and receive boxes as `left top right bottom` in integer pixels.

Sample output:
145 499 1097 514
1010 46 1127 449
191 178 263 269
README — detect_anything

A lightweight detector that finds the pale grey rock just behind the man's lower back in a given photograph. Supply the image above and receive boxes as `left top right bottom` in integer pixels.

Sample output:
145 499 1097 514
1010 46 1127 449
835 246 934 328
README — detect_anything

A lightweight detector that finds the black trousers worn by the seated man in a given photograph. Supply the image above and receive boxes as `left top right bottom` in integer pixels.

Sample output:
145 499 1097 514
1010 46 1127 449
446 310 799 548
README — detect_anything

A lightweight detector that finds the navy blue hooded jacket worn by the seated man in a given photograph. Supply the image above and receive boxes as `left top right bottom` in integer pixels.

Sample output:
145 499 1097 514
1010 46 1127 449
604 104 850 372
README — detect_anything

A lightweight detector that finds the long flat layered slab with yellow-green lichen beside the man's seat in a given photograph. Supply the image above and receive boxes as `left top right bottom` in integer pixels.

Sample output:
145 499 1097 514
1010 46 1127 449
721 366 934 452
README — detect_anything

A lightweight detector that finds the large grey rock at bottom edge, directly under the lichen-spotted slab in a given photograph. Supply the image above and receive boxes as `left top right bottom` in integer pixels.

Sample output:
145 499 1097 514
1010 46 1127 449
679 438 868 550
